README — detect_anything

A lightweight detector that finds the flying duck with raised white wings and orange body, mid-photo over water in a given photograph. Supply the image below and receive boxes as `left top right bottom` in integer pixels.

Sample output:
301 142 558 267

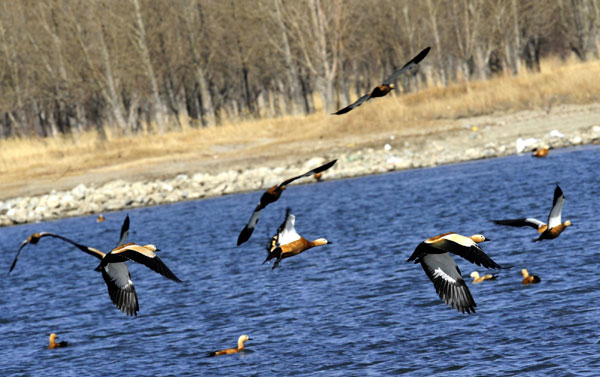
263 208 332 269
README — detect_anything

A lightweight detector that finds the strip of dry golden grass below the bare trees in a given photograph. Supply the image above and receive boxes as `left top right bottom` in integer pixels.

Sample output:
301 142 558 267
0 60 600 195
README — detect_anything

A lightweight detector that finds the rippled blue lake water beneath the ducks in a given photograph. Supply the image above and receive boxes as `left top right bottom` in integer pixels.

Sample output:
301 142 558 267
0 146 600 376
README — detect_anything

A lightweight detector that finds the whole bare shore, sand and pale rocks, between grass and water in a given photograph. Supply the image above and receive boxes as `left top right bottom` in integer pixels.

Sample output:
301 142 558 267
0 104 600 226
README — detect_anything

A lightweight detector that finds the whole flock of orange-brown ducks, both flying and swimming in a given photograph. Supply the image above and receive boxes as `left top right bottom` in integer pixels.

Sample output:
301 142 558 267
4 47 571 356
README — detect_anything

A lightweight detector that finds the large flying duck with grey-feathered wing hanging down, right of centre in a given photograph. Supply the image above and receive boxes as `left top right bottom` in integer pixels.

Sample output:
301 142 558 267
407 233 501 313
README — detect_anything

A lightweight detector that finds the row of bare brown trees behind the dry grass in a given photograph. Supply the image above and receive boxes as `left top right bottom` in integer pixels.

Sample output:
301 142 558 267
0 0 600 138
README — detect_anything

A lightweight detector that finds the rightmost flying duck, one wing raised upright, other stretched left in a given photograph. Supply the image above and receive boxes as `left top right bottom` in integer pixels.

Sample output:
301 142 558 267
493 185 573 242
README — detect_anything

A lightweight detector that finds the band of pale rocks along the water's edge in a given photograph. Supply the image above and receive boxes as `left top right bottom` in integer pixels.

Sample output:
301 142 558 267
0 121 600 226
